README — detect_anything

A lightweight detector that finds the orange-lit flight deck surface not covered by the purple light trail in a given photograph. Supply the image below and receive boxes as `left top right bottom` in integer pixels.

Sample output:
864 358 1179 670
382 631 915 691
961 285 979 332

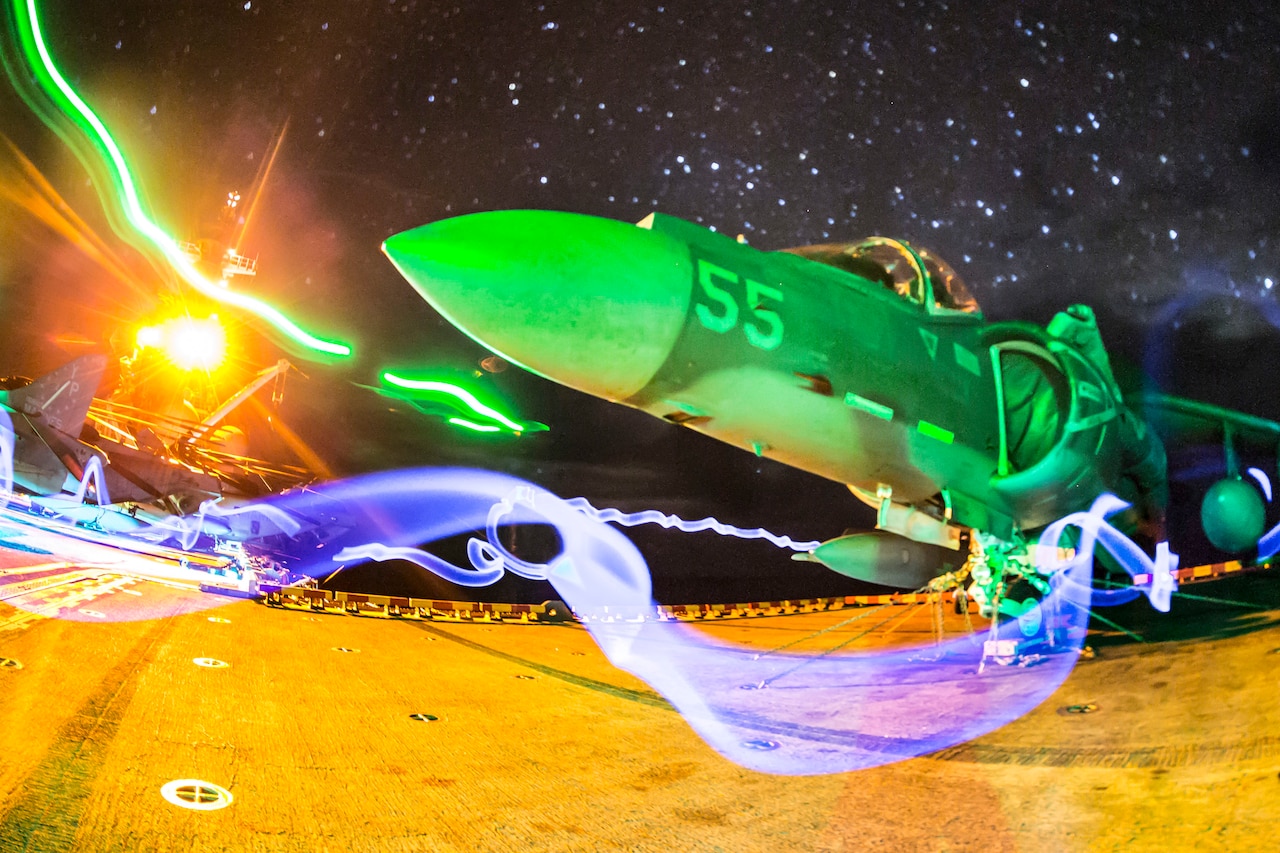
0 552 1280 853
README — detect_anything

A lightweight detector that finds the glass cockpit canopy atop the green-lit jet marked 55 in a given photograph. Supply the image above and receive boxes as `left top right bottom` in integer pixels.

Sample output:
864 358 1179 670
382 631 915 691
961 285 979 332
783 237 982 316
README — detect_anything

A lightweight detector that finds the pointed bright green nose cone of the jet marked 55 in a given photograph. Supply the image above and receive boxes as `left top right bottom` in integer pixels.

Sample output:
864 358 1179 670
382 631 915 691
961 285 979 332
383 210 692 400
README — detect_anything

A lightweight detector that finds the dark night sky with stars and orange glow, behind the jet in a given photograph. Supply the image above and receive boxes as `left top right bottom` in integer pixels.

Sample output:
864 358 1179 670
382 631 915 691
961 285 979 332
0 0 1280 601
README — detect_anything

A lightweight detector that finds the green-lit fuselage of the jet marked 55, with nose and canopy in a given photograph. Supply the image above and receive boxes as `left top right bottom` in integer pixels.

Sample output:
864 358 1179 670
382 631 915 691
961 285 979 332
383 211 1167 588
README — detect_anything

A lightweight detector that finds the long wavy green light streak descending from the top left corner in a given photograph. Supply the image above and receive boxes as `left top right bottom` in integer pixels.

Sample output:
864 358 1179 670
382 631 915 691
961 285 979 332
14 0 351 356
